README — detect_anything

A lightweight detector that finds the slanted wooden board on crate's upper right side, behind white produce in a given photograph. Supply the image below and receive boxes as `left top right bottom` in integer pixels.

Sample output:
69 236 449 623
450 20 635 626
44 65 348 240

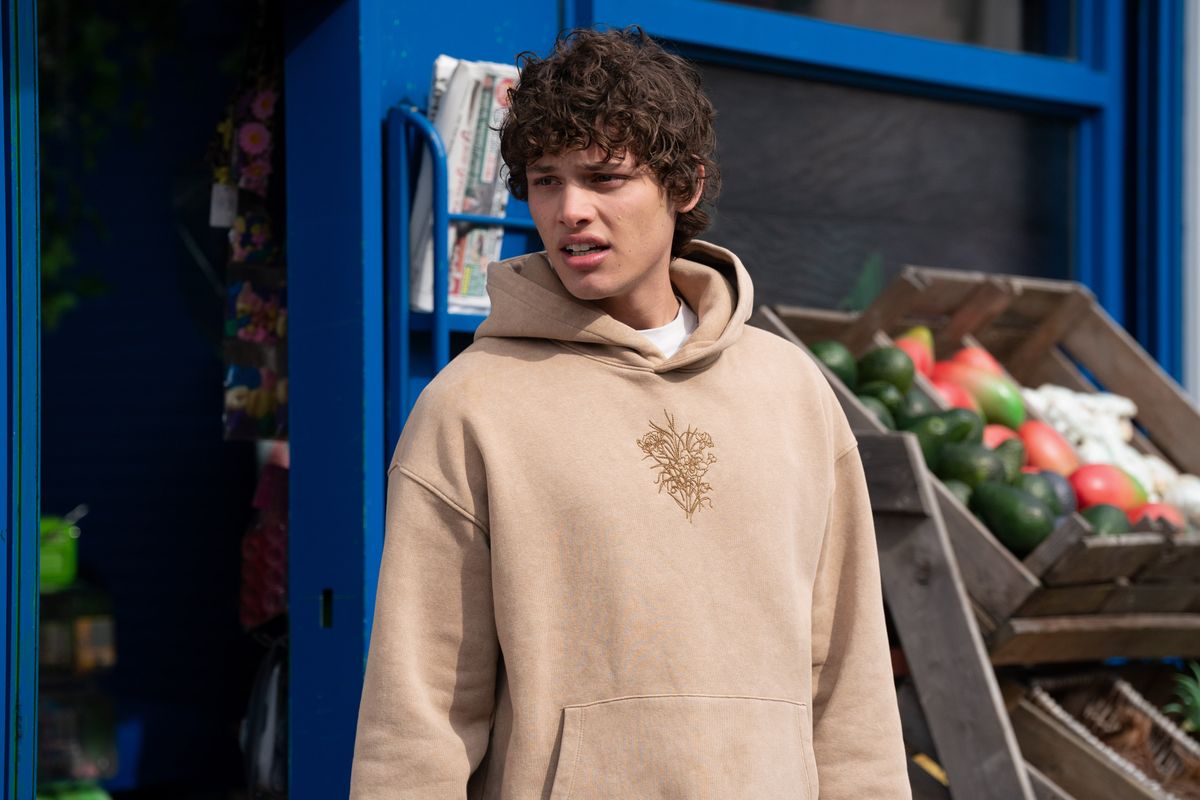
1063 303 1200 474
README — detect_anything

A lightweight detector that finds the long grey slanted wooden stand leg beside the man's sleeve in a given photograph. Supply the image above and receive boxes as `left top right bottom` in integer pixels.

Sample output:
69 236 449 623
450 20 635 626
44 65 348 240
859 434 1033 800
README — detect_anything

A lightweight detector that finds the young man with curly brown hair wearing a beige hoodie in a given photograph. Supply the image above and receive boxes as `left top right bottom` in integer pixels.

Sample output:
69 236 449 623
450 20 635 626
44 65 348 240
352 26 908 800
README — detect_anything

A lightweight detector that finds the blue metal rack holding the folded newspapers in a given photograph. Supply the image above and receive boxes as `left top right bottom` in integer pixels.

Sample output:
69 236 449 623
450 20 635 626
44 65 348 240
385 106 536 444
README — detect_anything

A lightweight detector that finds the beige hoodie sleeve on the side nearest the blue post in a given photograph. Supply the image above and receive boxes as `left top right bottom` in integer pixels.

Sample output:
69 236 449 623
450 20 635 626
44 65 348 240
350 465 499 800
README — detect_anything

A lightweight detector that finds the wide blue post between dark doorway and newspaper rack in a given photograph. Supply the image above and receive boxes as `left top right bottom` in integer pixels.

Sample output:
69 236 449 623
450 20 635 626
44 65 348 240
286 0 385 800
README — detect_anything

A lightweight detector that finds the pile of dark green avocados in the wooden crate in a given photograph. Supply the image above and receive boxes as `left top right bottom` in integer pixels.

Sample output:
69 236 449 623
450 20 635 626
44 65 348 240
810 341 1075 558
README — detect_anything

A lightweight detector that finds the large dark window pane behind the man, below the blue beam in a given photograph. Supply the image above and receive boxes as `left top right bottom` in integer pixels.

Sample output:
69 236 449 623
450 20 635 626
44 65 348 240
702 59 1074 307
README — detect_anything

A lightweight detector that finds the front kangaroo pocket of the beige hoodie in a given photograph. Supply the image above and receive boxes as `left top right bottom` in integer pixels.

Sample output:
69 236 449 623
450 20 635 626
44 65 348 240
550 694 817 800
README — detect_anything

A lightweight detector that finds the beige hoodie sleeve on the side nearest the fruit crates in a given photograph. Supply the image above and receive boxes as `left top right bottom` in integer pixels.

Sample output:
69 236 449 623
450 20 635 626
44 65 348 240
812 445 911 800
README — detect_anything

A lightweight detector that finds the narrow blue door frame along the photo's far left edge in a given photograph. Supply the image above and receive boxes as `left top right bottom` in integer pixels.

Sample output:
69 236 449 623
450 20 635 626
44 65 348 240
0 0 40 798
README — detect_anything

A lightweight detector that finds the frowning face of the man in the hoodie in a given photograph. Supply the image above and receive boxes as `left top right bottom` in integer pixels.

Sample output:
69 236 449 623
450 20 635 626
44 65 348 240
527 145 696 327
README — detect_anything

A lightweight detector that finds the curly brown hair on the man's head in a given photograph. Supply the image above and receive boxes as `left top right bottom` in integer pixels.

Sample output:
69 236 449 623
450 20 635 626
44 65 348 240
500 25 721 257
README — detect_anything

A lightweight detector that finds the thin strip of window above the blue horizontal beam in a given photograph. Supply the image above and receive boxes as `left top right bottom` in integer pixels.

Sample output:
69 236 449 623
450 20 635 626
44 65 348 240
727 0 1076 58
